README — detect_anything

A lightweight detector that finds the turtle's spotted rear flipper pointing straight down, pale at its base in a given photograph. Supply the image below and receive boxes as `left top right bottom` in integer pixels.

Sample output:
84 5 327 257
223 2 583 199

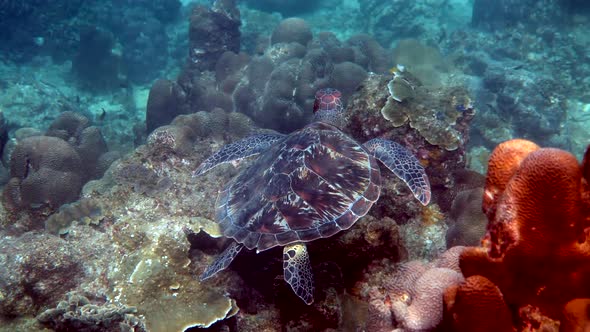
283 243 313 304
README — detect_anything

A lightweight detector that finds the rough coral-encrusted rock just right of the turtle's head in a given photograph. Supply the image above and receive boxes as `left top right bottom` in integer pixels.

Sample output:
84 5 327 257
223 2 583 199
347 75 474 218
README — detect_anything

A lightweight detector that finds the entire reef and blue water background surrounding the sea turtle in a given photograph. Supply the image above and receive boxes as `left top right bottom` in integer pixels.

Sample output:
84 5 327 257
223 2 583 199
0 0 590 331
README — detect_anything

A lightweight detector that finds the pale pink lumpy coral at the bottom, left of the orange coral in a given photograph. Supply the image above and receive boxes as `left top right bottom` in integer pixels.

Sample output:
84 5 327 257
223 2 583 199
356 247 464 332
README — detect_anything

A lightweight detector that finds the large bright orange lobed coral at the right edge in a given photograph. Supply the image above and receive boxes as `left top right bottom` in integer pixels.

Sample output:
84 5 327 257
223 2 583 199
460 140 590 319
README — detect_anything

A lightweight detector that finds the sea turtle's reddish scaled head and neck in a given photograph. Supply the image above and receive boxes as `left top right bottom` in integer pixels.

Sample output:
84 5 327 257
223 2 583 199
313 88 344 128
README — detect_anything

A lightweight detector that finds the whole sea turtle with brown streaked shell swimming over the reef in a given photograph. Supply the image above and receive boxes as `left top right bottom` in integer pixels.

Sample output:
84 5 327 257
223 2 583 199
194 88 431 304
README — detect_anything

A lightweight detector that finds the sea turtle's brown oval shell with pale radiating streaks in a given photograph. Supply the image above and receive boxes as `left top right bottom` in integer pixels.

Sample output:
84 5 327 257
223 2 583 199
216 122 381 251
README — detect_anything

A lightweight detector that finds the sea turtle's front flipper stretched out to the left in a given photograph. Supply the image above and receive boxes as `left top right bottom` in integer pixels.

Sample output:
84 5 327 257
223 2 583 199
193 134 284 176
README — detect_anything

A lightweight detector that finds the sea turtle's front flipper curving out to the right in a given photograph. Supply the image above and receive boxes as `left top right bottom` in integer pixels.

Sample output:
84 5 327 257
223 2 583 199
364 138 432 205
